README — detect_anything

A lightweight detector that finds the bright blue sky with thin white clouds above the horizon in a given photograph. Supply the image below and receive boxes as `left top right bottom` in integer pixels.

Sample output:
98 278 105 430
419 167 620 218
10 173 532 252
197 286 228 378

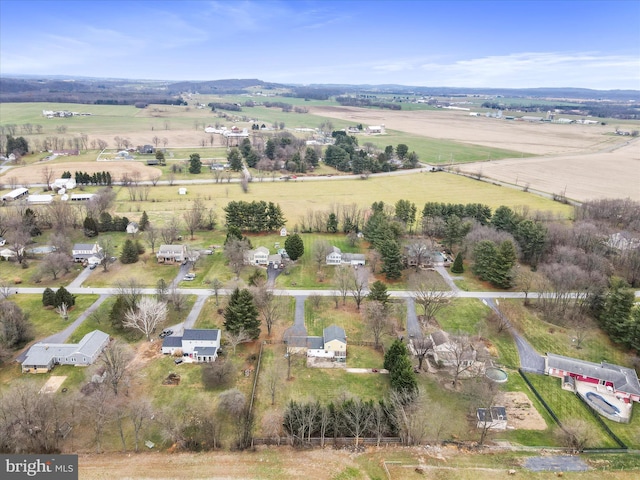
0 0 640 89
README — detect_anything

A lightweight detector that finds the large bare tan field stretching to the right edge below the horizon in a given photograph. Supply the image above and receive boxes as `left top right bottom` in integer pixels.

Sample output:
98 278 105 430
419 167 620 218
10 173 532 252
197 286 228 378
312 107 640 201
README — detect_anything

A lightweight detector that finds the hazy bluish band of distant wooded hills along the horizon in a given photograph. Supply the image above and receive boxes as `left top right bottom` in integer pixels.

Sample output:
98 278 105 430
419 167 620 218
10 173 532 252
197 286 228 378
0 76 640 106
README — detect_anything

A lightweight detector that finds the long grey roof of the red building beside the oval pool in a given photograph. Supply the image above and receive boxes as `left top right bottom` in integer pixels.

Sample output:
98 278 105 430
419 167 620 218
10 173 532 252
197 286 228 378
547 353 640 395
